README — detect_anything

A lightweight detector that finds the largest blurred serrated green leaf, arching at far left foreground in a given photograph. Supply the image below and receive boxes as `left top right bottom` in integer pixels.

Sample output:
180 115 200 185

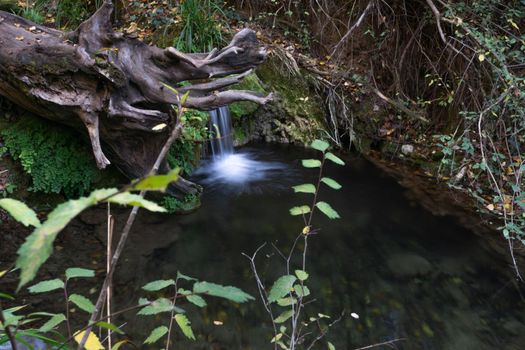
16 188 118 290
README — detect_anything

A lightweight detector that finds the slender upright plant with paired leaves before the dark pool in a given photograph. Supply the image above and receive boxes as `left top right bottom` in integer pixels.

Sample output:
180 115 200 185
244 140 345 350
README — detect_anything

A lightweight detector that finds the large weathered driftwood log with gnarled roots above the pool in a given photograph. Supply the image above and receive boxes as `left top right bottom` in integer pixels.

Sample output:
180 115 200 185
0 0 271 193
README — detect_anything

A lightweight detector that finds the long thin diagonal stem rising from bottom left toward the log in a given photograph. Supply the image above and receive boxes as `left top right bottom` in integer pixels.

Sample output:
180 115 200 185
77 98 183 350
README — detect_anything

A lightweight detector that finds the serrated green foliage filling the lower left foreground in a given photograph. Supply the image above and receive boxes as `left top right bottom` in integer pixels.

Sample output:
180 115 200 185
0 169 254 350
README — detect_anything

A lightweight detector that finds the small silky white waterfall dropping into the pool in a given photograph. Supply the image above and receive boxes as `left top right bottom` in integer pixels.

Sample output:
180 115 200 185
210 106 233 159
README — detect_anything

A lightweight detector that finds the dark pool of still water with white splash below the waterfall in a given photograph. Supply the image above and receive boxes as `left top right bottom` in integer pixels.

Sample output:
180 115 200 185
110 145 525 350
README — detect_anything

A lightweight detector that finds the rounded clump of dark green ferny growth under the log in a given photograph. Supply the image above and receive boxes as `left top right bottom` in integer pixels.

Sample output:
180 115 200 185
0 116 98 197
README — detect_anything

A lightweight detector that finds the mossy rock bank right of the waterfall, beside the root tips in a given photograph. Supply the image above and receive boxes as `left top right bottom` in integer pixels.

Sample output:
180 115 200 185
230 55 325 144
